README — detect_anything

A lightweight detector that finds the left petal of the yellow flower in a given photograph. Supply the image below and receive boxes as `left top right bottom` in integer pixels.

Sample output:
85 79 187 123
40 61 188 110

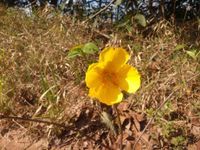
85 63 102 88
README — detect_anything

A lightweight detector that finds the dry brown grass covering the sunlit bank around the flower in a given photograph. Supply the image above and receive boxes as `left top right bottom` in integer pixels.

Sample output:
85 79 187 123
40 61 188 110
0 4 200 149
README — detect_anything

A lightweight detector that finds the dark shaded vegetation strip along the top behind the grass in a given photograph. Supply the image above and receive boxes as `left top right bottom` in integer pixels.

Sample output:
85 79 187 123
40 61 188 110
2 0 200 21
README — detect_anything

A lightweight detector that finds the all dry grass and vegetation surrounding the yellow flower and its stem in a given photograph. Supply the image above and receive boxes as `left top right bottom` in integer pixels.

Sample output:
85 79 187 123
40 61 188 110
0 0 200 150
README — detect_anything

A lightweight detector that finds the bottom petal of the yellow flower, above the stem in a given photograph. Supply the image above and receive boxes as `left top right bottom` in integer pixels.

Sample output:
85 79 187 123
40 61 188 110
89 83 123 105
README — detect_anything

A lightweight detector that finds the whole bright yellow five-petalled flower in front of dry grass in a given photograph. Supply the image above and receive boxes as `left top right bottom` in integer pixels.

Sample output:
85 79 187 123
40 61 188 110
85 48 141 105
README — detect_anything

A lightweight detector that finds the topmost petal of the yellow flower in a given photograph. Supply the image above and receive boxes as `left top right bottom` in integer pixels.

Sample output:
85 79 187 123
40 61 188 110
99 47 130 71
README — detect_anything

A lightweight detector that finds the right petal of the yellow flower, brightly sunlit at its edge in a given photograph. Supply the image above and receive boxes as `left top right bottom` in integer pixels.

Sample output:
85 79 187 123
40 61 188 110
117 64 141 93
